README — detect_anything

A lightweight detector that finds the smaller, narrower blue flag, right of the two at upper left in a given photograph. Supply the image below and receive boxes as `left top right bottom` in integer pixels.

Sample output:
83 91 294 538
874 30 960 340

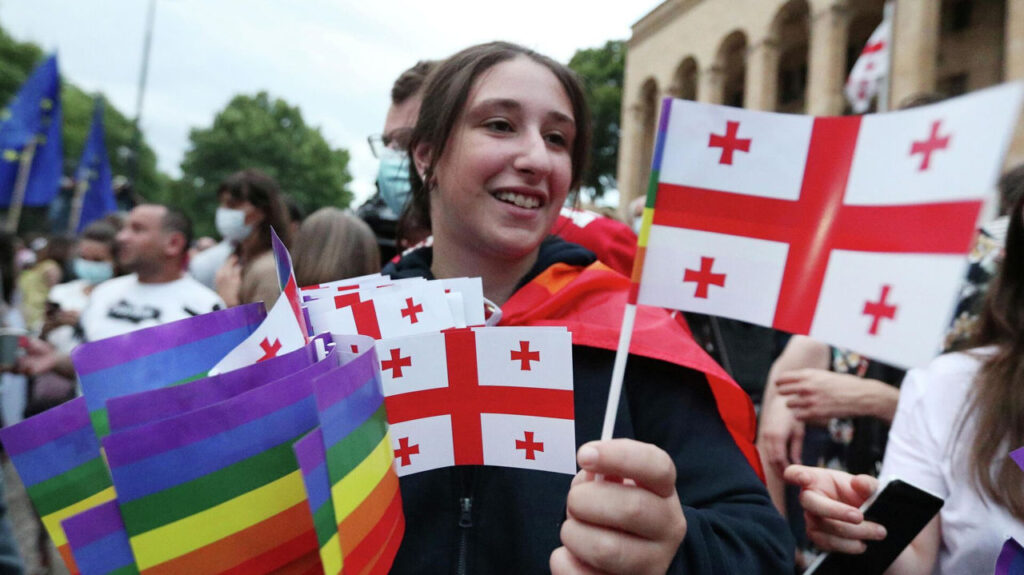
75 98 118 233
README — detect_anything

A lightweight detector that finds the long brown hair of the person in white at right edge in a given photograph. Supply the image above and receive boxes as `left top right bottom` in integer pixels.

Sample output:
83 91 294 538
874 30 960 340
959 192 1024 520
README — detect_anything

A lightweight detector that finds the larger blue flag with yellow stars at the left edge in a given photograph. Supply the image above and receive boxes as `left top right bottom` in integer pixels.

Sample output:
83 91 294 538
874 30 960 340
0 54 63 208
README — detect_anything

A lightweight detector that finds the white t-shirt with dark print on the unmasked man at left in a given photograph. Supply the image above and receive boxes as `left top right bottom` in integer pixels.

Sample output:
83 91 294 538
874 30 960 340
81 273 224 342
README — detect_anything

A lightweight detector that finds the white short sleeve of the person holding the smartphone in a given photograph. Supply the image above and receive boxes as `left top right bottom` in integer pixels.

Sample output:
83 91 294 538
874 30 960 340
880 369 949 498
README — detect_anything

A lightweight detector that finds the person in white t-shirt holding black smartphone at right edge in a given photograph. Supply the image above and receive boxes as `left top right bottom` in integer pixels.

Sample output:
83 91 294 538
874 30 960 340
785 187 1024 574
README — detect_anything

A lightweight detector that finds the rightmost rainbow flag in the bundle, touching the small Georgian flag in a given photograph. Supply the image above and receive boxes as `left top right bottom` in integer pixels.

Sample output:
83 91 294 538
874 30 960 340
313 343 406 574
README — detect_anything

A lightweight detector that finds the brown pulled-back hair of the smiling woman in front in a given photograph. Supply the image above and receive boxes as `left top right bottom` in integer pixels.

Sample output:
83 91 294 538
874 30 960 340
401 42 591 237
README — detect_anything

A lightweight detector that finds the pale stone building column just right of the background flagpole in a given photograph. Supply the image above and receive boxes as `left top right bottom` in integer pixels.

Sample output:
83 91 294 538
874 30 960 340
889 0 942 108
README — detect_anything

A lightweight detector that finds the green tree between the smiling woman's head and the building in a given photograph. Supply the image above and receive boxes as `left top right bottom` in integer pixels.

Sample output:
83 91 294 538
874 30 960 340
569 40 626 197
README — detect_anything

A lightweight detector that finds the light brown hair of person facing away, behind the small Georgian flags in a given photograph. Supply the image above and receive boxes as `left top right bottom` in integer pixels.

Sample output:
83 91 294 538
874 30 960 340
292 208 380 285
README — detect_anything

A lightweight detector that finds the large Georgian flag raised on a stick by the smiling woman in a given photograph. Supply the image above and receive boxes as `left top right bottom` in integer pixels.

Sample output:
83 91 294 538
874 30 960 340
634 84 1022 365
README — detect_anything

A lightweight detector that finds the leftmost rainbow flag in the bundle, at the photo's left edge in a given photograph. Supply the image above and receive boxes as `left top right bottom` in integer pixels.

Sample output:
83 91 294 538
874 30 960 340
0 397 115 574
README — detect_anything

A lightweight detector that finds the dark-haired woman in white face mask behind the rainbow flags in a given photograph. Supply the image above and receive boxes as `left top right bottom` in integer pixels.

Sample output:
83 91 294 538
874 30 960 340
214 169 292 307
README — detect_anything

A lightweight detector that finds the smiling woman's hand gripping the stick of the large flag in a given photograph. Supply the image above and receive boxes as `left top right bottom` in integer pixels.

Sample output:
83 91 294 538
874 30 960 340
550 439 686 574
